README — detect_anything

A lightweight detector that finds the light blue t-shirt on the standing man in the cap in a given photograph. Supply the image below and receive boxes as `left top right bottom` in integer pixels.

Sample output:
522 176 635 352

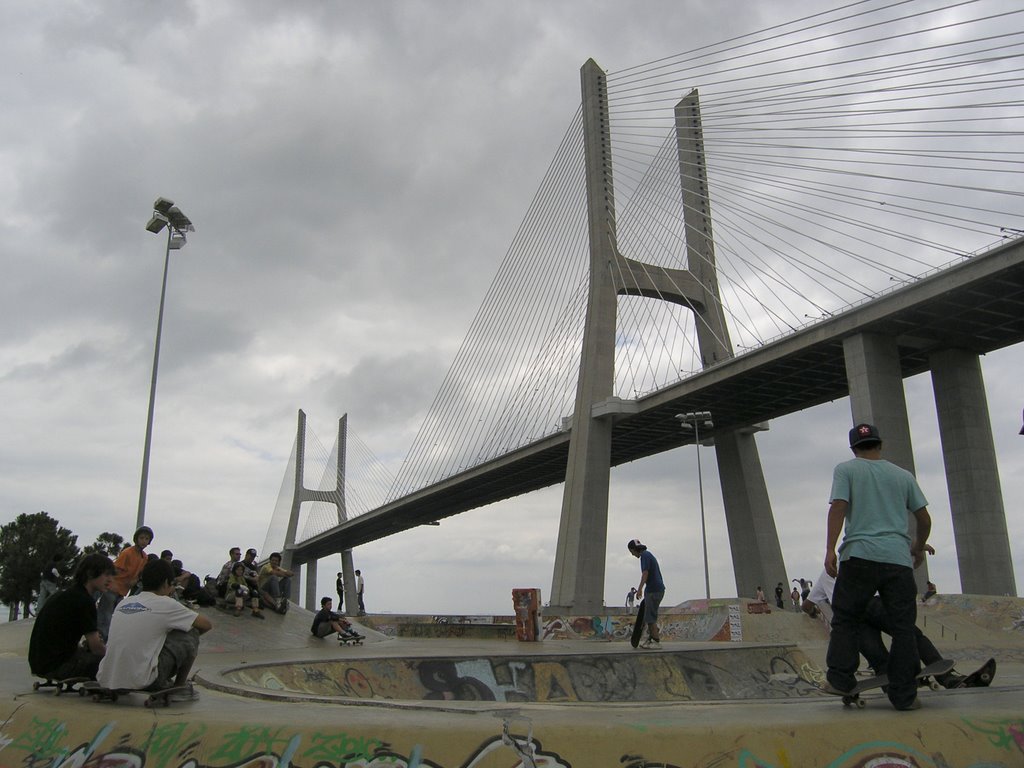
830 458 928 567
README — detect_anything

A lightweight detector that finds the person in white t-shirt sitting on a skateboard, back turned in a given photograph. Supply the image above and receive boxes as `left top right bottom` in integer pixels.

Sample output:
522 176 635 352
96 560 213 699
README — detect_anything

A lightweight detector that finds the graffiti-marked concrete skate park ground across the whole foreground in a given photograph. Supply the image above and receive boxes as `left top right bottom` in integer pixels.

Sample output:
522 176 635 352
0 595 1024 768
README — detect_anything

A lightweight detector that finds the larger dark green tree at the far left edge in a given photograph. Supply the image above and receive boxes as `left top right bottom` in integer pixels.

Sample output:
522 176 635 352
0 512 78 618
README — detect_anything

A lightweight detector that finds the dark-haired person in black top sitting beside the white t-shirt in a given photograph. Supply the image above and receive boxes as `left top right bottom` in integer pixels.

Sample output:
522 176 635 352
29 553 114 680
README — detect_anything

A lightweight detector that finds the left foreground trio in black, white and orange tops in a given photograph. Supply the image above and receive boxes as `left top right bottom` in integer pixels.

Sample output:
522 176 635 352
29 526 213 701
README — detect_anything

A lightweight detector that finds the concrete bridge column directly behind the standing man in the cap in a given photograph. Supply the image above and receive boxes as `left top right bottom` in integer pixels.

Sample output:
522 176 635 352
837 333 928 592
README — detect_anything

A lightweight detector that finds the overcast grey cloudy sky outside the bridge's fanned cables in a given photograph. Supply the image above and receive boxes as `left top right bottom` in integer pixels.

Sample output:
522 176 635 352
0 0 1024 613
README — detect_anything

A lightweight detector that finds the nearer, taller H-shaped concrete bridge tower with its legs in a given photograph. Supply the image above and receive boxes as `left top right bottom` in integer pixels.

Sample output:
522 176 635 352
551 59 785 612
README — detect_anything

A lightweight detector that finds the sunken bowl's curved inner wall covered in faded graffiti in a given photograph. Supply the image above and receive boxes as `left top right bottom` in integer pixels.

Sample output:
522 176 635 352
211 645 820 703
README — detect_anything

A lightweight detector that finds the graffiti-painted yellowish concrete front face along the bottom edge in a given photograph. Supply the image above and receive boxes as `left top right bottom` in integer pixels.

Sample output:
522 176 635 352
0 715 1024 768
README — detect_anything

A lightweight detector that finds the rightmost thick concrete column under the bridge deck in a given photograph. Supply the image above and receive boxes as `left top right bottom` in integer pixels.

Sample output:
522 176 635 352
931 349 1017 595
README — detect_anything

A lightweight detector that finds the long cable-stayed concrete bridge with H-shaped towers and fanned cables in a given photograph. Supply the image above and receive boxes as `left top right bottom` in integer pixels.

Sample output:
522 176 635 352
264 2 1024 610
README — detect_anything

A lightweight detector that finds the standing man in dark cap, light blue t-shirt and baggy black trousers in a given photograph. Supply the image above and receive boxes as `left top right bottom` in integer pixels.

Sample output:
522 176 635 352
824 424 932 710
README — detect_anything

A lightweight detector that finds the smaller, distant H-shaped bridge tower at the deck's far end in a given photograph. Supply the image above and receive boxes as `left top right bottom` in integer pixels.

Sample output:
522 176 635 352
282 410 356 612
